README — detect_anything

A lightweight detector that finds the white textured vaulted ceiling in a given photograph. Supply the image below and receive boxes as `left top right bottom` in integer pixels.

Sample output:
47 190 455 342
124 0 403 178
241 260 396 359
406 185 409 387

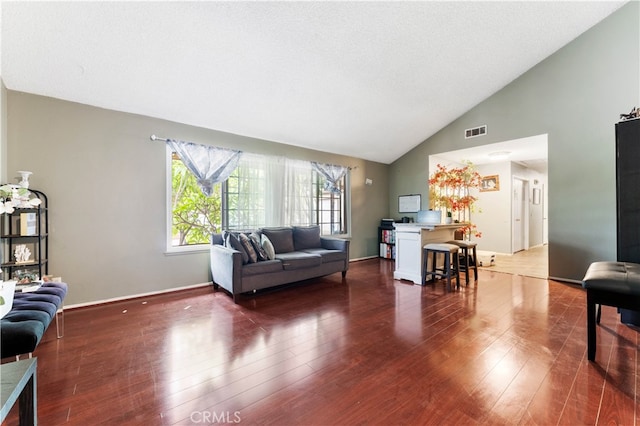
1 1 625 163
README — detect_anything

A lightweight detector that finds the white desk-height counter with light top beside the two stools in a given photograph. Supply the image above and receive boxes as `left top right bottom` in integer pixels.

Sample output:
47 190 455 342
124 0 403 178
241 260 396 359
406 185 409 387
393 223 463 285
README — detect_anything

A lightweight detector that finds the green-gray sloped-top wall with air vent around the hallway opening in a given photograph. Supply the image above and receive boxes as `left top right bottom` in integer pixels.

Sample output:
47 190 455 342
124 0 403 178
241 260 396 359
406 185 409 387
389 2 640 281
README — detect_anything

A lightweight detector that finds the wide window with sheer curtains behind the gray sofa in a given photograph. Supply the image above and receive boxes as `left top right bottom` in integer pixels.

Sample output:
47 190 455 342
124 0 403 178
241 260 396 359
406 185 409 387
167 149 349 249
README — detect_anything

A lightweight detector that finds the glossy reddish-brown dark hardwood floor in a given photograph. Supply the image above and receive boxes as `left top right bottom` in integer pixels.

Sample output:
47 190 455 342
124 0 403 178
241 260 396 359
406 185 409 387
5 259 640 426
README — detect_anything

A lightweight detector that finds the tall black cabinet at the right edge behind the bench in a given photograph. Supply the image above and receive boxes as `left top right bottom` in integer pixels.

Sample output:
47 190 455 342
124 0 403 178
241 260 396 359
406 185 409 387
616 119 640 325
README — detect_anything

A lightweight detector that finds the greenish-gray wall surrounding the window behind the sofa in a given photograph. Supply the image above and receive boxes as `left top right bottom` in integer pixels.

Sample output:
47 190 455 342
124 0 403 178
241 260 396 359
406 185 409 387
6 94 389 305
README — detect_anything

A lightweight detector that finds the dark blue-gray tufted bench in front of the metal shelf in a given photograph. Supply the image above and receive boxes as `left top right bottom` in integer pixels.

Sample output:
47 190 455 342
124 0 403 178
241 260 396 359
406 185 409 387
0 282 67 358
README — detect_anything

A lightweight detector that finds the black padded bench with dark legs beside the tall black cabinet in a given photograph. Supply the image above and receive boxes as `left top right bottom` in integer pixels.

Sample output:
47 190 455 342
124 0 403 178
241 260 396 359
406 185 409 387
582 262 640 361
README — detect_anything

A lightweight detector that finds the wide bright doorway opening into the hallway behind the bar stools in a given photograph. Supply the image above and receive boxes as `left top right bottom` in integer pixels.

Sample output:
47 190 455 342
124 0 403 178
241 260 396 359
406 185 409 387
429 134 548 278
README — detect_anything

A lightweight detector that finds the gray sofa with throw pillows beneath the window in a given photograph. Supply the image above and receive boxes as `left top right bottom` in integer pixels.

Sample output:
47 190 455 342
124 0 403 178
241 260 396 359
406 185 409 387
210 226 349 303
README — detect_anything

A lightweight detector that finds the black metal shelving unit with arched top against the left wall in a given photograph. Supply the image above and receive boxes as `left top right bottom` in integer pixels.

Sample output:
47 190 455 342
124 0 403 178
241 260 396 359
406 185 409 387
0 189 49 280
